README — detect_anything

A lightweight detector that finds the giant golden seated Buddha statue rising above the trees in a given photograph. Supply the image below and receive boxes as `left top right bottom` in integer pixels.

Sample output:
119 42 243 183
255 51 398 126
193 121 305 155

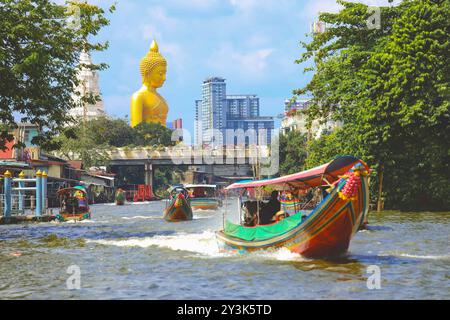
130 40 169 127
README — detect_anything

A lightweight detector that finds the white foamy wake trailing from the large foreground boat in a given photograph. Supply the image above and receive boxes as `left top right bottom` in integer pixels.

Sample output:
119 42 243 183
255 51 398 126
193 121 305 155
86 230 309 262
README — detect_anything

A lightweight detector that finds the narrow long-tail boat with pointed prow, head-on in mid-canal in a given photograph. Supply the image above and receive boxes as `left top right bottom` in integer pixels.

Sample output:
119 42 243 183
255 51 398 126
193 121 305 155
164 186 193 222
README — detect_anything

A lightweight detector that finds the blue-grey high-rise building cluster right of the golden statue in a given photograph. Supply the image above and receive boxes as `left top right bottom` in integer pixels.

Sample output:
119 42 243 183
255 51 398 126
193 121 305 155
194 77 274 145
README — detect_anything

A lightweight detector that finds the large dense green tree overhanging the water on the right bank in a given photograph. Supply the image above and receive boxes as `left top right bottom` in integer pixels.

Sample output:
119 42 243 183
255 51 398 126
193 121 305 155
295 0 450 210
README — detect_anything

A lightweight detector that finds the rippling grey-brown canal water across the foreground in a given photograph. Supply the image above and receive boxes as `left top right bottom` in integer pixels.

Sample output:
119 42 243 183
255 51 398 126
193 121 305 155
0 199 450 299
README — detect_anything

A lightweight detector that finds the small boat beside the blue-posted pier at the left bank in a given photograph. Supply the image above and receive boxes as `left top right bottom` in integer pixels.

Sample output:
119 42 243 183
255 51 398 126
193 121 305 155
56 186 91 222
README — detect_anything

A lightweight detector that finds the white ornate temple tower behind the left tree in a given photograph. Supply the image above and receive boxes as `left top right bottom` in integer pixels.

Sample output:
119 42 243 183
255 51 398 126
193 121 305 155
69 51 105 121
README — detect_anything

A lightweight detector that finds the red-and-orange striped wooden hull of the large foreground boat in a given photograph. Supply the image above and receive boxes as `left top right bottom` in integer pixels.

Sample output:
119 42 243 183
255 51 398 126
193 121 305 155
216 177 369 258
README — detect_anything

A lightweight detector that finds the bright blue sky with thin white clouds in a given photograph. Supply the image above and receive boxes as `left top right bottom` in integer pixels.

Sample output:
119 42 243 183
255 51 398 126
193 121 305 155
69 0 400 140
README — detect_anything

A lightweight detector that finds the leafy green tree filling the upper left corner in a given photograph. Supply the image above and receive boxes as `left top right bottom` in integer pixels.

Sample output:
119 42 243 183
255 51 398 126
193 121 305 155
0 0 114 148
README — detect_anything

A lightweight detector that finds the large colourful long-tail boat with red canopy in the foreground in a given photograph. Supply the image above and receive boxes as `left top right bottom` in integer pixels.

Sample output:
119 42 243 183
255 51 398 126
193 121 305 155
216 156 369 258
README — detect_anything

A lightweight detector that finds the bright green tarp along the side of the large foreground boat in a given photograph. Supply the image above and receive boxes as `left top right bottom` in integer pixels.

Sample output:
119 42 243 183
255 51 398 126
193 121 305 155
224 212 302 241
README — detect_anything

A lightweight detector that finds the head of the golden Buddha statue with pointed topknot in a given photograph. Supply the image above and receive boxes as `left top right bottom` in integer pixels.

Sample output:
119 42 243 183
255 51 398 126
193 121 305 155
140 40 167 88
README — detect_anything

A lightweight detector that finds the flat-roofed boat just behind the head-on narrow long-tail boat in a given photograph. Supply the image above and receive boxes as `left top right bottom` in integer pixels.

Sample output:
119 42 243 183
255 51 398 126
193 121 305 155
184 184 221 210
